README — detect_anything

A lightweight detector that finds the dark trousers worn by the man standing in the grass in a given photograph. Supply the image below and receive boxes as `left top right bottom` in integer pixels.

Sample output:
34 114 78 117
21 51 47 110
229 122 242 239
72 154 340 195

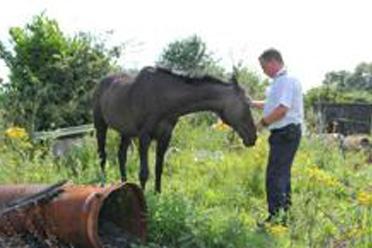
266 124 301 217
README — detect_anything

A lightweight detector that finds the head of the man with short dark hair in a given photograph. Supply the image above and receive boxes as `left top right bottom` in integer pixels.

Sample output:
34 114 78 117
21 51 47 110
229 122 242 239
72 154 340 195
258 48 284 78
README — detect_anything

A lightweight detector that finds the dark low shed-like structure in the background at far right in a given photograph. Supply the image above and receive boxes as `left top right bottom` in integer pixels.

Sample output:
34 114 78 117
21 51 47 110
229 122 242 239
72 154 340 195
313 103 372 135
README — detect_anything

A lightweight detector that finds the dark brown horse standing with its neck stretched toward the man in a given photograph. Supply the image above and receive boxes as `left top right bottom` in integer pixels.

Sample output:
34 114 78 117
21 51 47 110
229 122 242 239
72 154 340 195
93 67 257 192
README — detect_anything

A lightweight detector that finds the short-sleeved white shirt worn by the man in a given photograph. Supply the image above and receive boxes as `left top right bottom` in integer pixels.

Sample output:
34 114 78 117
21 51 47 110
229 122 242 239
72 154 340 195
263 70 304 130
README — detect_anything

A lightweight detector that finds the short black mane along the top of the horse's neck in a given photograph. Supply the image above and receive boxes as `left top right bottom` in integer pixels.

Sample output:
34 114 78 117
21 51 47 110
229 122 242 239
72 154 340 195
146 66 230 85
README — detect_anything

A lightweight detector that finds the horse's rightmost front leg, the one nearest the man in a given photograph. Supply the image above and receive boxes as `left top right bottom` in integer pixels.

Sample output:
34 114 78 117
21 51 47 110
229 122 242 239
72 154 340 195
155 133 171 193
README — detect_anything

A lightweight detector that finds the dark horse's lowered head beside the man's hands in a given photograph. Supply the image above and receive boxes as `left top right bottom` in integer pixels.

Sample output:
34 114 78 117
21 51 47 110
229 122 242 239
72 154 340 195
220 71 257 146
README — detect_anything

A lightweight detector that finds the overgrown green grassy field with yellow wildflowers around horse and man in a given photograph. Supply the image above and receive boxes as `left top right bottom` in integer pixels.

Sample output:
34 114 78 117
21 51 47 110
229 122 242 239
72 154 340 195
0 118 372 248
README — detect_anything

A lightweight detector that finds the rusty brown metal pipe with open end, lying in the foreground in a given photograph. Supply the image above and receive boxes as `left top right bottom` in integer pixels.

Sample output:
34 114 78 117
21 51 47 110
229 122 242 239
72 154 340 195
0 183 147 248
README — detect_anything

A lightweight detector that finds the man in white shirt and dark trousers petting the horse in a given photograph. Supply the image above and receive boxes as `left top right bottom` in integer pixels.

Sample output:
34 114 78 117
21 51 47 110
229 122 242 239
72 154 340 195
252 49 303 224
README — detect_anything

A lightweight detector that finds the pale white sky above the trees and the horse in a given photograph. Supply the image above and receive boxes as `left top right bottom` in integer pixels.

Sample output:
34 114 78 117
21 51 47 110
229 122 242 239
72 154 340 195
0 0 372 90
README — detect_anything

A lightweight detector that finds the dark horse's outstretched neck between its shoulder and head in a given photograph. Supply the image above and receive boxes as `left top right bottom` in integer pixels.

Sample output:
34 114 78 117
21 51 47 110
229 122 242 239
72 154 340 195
167 84 230 115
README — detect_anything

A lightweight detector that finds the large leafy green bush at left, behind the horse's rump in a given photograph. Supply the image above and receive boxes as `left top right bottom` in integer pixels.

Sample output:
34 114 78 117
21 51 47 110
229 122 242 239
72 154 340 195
0 14 119 130
